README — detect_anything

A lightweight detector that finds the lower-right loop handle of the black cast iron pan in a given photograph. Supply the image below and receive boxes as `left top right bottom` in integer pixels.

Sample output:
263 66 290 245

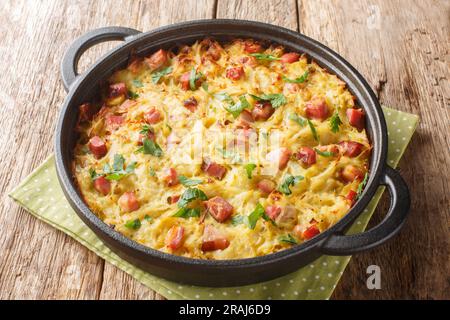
321 166 411 255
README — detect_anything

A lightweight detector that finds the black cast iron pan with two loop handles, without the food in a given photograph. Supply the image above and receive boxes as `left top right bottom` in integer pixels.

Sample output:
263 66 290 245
55 20 410 286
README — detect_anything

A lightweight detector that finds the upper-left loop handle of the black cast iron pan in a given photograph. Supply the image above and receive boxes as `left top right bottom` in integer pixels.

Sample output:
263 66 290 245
61 27 141 91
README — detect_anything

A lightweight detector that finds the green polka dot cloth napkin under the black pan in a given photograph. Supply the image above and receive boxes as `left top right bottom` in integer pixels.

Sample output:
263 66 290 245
10 108 418 299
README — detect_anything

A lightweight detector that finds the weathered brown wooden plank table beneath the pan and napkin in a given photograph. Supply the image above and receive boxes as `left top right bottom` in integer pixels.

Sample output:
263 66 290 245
0 0 450 299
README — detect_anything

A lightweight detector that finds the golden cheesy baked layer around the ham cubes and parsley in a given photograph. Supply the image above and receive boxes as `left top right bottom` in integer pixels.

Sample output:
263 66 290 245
73 41 370 259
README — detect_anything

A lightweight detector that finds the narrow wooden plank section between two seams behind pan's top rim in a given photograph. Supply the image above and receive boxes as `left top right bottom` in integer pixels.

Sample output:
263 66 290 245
217 0 298 30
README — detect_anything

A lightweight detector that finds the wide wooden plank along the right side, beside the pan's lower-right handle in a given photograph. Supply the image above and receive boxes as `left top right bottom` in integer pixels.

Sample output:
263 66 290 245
298 0 450 299
